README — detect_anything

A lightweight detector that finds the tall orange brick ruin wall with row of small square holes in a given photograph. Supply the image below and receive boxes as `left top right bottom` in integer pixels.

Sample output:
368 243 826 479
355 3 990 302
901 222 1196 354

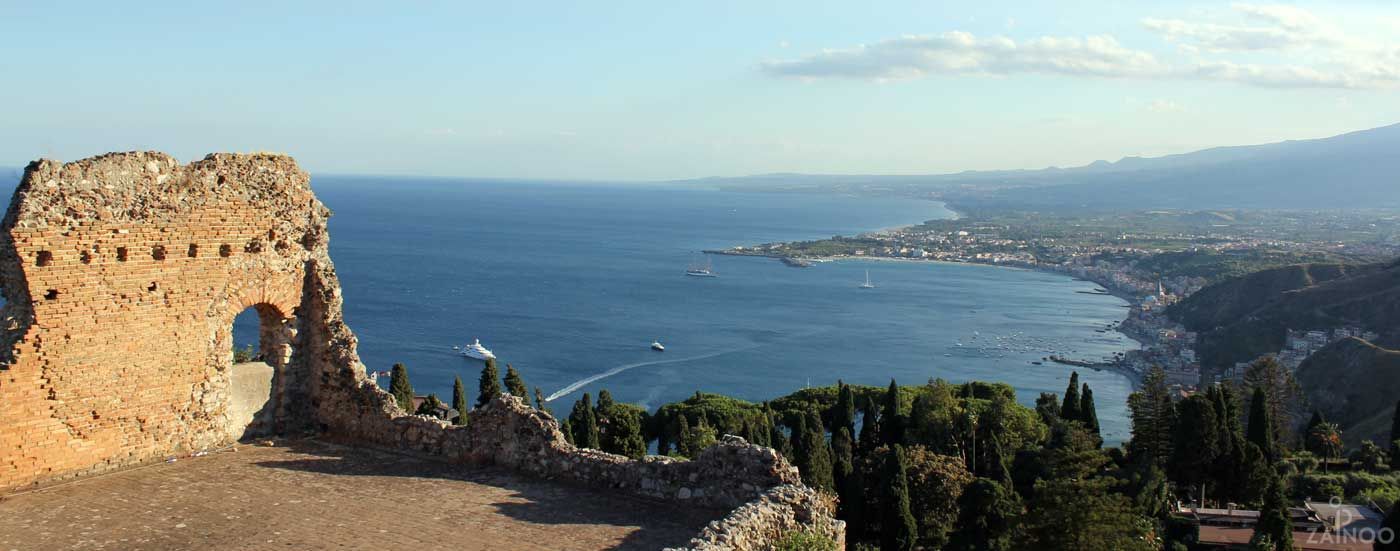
0 152 329 488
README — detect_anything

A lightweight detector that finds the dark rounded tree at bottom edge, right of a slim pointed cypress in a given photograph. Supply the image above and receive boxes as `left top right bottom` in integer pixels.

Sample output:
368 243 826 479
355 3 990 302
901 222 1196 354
946 478 1021 551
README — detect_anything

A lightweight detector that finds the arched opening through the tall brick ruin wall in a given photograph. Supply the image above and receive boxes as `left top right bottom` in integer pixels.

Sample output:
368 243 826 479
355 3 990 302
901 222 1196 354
228 303 294 439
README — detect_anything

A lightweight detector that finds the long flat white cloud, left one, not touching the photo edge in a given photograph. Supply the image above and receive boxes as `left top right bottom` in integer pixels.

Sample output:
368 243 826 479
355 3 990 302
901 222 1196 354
762 31 1162 81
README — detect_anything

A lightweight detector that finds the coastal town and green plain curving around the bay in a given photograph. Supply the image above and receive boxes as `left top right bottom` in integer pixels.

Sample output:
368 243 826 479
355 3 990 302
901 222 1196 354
707 206 1400 392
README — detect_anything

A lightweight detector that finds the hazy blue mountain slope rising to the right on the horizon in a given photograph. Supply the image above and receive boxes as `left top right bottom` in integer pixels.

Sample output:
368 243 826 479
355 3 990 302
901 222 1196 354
685 124 1400 210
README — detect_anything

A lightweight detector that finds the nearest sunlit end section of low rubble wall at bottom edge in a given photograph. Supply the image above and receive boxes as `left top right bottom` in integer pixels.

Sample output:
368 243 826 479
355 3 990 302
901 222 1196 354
668 485 846 551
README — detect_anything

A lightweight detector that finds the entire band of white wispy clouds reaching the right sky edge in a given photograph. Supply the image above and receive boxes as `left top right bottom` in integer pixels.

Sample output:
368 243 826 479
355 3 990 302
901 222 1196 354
760 4 1400 88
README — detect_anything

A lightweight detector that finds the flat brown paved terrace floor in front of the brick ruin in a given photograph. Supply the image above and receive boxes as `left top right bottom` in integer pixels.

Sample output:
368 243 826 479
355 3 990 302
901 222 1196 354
0 441 724 551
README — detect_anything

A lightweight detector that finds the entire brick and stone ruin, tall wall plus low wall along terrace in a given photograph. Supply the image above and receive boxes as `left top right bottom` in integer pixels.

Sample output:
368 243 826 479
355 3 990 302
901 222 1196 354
0 152 844 548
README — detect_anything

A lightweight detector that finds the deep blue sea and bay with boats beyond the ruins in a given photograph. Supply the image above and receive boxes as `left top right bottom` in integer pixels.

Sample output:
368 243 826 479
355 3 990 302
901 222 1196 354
270 176 1135 442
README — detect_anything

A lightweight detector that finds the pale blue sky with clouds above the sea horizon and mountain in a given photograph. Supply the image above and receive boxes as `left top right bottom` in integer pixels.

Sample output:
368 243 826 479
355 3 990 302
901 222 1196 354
0 0 1400 180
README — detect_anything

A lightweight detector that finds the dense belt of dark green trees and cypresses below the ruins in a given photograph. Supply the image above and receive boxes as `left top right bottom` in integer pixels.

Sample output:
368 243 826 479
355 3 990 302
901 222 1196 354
391 351 1400 551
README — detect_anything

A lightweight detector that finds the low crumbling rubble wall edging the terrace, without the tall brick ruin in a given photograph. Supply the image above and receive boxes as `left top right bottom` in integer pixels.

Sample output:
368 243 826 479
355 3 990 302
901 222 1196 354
332 387 846 551
